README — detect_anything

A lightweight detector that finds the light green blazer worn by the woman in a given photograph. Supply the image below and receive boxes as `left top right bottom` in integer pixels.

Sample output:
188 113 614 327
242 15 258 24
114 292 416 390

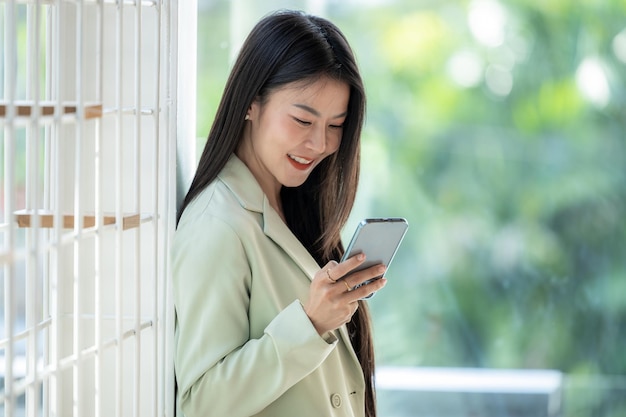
171 156 365 417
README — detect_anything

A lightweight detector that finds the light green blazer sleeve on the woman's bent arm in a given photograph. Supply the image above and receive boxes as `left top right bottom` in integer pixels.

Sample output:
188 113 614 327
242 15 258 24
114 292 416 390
172 217 336 417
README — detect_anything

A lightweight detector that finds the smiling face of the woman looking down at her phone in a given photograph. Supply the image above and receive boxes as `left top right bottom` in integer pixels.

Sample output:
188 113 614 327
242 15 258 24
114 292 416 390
237 77 350 198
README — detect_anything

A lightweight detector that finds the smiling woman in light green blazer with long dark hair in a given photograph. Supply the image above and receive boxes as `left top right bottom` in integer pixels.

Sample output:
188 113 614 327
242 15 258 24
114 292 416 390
171 11 386 417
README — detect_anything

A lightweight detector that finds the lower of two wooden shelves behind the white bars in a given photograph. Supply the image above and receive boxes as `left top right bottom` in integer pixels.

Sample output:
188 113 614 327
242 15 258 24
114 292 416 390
15 210 150 230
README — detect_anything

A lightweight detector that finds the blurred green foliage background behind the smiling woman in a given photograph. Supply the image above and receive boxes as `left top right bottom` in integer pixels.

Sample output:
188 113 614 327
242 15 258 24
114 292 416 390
198 0 626 416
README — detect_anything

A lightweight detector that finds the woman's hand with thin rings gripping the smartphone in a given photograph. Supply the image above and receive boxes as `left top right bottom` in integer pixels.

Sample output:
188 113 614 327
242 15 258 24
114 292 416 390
304 254 387 335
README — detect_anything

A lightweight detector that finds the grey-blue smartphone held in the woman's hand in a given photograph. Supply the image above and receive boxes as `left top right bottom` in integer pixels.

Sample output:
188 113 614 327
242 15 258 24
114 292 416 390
341 217 409 298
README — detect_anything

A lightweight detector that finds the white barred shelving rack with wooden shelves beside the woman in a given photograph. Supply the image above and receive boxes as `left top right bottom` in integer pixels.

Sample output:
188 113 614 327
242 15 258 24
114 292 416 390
0 0 195 417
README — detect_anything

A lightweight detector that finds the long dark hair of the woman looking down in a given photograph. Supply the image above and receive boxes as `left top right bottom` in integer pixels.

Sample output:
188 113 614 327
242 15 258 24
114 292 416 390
177 10 376 417
